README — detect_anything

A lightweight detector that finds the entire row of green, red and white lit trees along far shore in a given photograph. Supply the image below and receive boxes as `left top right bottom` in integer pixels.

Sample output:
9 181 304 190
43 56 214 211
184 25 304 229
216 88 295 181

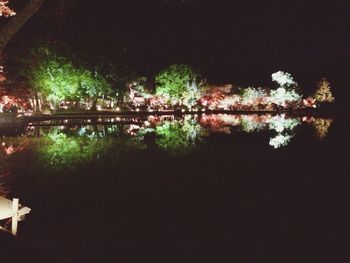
0 44 334 113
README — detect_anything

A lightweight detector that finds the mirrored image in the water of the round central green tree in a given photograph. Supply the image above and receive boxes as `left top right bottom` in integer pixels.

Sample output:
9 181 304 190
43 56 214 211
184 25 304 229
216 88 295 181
156 118 206 157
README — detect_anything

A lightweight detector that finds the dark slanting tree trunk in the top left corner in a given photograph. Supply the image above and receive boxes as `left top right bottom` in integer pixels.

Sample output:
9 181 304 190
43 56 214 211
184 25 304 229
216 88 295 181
0 0 45 53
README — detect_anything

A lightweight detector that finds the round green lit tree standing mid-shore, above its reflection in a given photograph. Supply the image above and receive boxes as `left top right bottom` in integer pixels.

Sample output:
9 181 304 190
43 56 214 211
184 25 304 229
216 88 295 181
156 64 201 105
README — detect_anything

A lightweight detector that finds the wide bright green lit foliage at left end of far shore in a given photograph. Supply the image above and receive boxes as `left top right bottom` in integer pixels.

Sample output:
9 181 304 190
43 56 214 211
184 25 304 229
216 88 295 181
24 46 112 105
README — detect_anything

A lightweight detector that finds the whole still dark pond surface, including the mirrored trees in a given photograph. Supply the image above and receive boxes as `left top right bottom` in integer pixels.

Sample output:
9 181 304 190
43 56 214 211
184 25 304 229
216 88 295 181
0 115 350 263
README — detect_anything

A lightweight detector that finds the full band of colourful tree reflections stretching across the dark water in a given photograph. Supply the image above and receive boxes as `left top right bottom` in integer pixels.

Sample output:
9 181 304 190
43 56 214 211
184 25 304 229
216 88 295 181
0 114 333 174
